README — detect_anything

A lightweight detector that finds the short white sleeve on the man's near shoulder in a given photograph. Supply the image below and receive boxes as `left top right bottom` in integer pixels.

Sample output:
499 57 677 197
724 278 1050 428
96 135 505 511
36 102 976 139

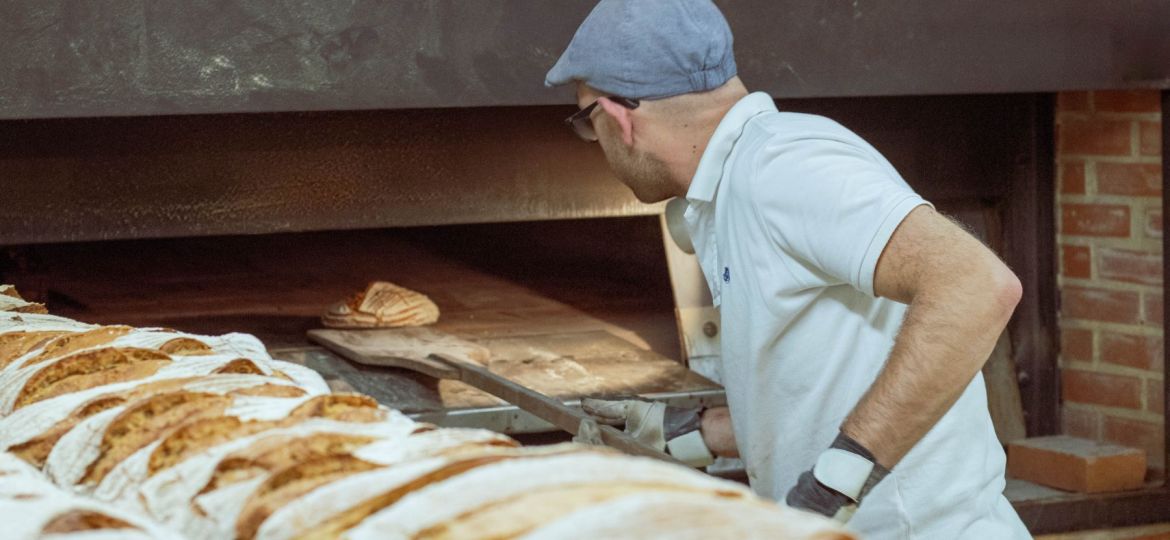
749 139 929 296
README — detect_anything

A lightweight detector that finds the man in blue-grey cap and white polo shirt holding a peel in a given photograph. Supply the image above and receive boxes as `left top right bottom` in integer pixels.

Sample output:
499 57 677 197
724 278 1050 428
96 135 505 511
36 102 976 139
545 0 1028 539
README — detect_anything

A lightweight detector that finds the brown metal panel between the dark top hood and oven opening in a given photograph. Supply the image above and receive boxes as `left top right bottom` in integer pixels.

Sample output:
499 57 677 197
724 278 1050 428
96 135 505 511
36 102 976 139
0 95 1034 244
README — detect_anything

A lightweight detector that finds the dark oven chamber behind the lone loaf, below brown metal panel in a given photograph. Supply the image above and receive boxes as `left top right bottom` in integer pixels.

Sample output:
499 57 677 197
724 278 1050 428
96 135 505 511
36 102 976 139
9 226 677 358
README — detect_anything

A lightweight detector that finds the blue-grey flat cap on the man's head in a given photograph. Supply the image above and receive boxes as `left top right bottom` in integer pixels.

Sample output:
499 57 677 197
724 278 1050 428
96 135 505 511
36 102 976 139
544 0 736 99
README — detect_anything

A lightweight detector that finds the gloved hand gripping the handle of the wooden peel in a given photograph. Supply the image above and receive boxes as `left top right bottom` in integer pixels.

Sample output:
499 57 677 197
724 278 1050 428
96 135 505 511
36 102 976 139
581 397 715 466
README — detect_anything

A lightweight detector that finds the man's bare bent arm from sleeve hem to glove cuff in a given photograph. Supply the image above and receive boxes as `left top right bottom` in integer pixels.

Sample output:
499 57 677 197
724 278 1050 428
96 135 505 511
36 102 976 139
841 206 1021 469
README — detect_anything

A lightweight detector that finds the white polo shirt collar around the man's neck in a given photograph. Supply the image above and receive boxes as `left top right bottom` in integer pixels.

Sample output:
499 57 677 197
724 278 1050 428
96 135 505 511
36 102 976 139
687 92 776 202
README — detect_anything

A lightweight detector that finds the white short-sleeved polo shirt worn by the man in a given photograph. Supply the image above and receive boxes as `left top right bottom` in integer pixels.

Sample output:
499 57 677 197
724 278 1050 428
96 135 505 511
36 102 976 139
684 92 1030 539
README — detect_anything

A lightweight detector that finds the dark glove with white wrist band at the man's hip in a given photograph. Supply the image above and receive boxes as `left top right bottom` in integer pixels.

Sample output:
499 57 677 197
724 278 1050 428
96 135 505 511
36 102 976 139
785 434 889 524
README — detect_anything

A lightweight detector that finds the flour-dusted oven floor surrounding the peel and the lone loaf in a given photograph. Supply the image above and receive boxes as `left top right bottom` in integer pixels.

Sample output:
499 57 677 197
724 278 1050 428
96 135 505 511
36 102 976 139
2 221 718 413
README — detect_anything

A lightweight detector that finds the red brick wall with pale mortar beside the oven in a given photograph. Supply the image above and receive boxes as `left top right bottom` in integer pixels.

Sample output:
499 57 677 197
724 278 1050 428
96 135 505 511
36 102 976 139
1057 91 1164 469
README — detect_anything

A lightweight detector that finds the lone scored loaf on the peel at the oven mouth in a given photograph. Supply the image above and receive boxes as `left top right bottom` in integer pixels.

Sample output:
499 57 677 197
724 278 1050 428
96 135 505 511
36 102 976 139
321 282 439 328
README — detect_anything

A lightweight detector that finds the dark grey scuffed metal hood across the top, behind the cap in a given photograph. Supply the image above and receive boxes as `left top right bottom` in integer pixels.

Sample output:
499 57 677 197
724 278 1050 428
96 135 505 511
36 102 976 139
0 0 1170 118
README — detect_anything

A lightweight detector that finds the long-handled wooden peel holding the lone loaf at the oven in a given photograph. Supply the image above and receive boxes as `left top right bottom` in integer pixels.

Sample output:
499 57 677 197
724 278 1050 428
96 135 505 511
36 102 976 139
309 327 681 464
